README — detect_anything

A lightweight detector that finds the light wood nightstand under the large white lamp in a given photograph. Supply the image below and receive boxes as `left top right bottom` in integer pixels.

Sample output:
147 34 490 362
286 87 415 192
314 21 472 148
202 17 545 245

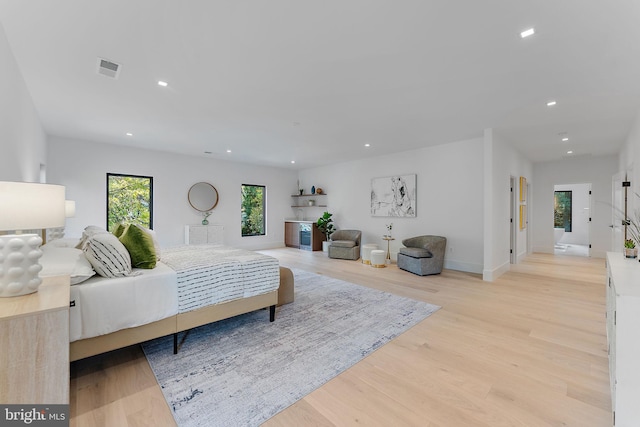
0 276 70 404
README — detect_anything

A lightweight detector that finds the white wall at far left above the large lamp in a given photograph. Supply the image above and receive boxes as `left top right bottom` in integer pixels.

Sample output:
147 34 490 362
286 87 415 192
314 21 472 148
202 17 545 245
0 24 46 182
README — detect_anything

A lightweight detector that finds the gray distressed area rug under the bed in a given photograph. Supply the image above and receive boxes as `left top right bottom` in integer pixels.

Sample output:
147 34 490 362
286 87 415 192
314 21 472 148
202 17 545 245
142 270 439 427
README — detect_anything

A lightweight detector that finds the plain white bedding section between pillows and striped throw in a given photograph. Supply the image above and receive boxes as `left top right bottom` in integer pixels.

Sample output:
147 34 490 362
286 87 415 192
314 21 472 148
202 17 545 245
69 262 178 341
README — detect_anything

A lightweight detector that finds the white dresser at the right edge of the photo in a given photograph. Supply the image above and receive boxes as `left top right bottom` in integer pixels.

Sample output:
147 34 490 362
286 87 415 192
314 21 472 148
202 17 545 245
607 252 640 427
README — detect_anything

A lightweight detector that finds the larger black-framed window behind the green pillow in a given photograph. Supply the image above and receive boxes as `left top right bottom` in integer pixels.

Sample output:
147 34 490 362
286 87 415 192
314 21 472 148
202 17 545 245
107 173 153 231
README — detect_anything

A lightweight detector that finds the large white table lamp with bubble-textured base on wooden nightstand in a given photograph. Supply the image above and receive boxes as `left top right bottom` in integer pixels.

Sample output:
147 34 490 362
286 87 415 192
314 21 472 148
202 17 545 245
0 181 65 297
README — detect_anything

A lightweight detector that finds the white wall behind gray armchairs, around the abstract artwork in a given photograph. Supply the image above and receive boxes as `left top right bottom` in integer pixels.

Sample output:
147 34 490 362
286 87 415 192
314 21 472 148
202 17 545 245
292 139 483 273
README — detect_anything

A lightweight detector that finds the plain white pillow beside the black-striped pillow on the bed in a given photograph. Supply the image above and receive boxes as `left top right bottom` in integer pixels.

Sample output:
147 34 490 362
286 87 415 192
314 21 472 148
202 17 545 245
39 244 96 285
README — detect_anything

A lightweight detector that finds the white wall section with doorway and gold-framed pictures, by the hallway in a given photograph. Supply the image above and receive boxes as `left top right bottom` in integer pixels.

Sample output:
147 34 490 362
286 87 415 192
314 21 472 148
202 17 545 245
483 129 534 281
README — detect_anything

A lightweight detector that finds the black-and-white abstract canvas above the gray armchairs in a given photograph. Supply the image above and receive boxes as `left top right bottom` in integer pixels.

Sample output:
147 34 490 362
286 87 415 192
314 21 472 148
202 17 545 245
371 174 416 218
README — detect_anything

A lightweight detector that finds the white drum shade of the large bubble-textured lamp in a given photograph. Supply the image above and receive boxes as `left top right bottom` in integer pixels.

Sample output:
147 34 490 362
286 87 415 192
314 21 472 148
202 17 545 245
0 181 65 230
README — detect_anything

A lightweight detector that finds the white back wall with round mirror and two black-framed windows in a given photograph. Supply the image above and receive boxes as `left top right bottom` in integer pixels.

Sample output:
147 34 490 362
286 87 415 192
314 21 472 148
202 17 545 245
48 138 297 249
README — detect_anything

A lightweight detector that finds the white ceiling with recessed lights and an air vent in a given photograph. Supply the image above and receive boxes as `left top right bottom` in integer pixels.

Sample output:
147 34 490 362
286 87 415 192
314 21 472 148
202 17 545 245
0 0 640 168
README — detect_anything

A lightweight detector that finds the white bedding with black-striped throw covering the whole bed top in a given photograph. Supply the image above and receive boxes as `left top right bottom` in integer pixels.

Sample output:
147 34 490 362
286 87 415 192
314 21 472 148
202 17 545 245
70 245 280 342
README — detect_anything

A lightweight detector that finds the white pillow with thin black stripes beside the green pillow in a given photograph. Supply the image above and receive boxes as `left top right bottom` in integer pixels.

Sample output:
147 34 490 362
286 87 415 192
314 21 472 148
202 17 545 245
82 233 131 277
